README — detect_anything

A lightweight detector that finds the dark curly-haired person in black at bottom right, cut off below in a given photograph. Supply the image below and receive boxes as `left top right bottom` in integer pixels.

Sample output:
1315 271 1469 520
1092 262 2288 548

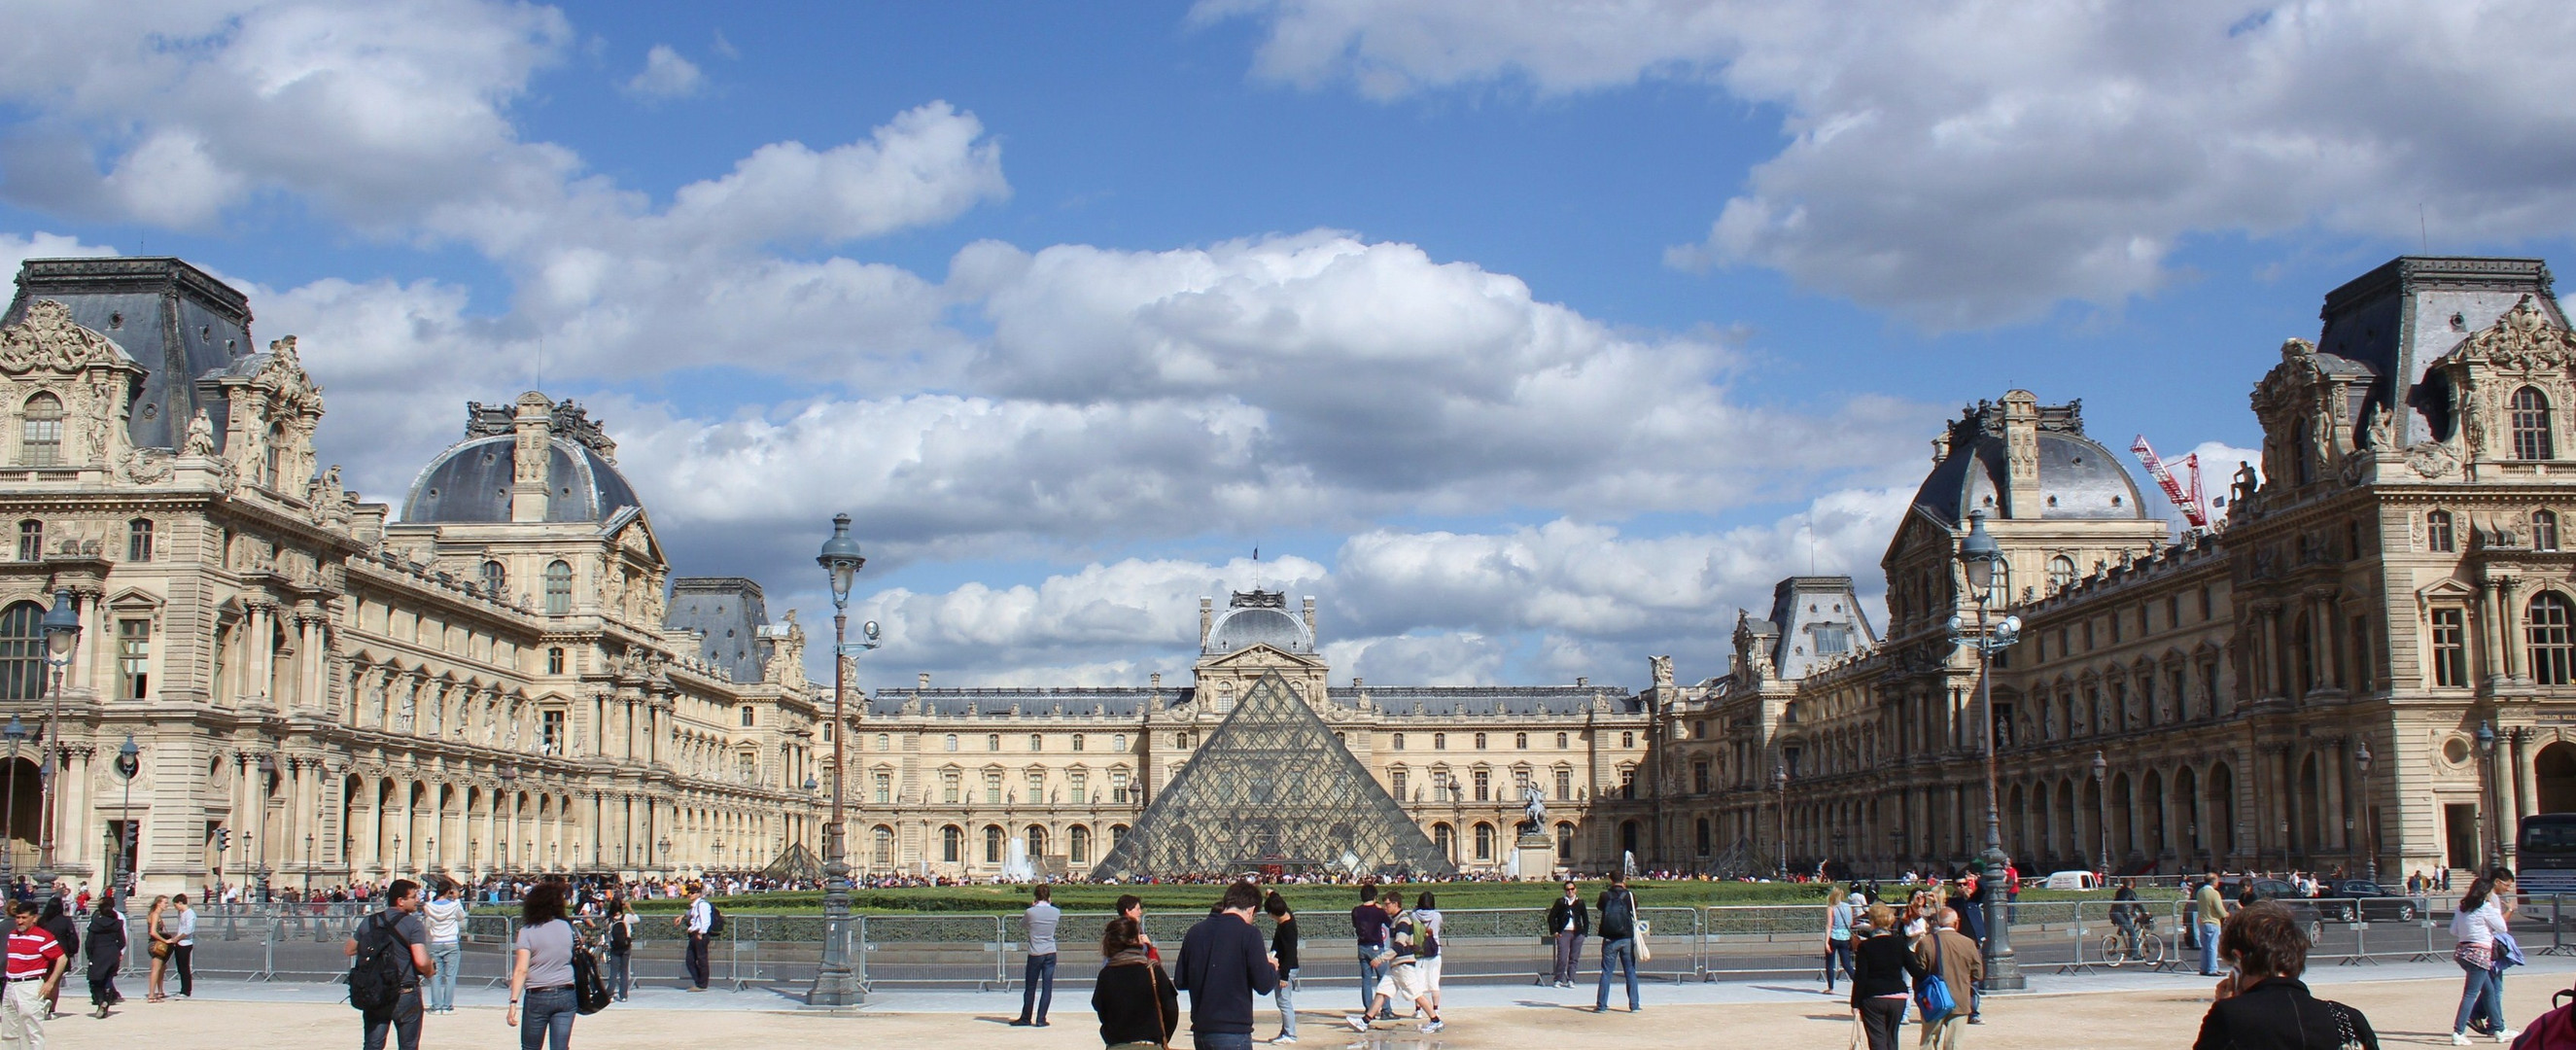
2192 900 2380 1050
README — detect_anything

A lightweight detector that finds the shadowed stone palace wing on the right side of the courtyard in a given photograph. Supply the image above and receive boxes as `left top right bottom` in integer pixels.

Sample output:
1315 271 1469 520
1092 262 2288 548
1649 258 2576 878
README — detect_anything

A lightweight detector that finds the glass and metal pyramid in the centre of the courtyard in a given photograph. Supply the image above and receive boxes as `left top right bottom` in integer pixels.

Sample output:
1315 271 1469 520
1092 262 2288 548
1093 675 1458 880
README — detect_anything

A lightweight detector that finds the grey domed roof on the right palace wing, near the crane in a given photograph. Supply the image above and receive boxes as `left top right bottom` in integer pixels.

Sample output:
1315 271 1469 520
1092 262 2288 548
1914 404 2145 525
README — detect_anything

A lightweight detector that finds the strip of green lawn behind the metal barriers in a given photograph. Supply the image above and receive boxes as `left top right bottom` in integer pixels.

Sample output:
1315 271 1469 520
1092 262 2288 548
637 880 2176 916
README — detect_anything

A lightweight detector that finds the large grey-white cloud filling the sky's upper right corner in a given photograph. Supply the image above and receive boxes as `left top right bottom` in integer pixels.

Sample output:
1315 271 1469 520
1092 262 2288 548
1198 0 2576 330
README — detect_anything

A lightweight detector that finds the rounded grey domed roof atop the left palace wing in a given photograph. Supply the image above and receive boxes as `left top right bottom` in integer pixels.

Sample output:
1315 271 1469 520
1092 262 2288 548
401 435 642 522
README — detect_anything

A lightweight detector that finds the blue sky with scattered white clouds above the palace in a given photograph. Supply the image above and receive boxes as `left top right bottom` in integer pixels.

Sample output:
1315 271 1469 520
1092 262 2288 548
0 0 2576 687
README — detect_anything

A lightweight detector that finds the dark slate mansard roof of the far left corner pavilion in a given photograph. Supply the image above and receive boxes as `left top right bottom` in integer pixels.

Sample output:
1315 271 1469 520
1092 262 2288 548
0 258 253 448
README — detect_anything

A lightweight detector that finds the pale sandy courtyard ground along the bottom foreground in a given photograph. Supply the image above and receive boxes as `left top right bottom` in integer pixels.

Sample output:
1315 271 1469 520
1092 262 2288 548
47 958 2576 1050
